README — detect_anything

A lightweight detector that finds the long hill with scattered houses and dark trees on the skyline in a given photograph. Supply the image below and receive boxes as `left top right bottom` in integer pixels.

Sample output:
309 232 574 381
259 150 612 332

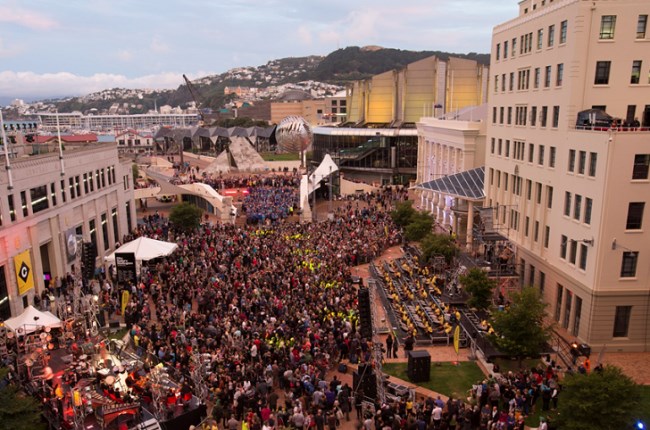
54 46 490 114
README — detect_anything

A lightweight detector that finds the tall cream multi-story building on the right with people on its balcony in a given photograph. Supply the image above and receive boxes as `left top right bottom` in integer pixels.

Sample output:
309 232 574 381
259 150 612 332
485 0 650 351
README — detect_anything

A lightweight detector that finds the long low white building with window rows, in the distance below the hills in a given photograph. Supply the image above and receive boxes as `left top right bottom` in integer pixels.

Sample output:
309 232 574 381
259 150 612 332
37 112 199 132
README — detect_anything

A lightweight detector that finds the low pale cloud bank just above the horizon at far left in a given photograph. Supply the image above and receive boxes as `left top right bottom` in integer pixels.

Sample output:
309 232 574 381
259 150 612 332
0 71 215 100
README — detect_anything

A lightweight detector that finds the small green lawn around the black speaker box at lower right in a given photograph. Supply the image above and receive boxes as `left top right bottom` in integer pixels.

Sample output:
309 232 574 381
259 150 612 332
383 361 485 398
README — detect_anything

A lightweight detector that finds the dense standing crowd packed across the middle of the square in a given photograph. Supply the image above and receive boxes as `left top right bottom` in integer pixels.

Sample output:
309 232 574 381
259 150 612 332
106 183 401 428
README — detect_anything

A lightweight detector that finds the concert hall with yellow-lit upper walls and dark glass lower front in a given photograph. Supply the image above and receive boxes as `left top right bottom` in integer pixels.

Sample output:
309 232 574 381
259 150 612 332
314 56 488 184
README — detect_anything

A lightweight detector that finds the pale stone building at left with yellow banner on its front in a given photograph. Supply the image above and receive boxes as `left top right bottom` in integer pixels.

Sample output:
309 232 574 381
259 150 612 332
0 144 136 319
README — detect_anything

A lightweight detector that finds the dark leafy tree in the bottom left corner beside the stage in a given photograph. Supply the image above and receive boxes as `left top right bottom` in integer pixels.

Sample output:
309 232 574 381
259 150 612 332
0 368 45 430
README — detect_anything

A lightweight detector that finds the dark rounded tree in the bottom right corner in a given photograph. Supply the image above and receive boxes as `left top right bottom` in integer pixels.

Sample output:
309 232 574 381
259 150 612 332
554 366 642 430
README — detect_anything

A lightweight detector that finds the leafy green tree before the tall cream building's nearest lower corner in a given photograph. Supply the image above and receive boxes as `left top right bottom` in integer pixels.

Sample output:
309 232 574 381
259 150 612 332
491 287 551 364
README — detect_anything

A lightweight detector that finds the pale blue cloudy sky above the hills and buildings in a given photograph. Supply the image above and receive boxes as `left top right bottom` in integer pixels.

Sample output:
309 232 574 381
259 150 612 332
0 0 518 104
